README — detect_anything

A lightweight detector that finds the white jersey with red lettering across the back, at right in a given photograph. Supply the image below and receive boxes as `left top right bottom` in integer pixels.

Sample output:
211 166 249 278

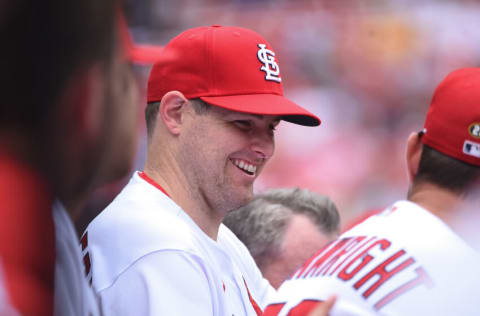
265 201 480 316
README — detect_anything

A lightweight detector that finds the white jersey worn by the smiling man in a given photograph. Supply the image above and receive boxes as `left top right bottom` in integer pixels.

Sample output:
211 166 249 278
82 172 274 316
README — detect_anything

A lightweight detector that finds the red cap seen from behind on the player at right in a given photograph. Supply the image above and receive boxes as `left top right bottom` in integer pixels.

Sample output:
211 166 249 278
422 68 480 166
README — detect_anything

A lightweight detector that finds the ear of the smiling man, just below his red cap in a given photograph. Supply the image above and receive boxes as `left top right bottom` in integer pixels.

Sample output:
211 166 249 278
158 91 188 135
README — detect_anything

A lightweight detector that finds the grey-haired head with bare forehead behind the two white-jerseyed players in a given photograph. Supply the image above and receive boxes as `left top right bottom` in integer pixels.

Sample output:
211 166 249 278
223 188 340 289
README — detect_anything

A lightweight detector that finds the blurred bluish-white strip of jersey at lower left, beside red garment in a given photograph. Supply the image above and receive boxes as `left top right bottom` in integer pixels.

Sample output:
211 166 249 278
53 201 99 316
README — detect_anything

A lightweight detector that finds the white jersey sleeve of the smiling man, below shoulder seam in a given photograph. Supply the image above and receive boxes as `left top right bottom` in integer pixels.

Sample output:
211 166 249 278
99 250 215 316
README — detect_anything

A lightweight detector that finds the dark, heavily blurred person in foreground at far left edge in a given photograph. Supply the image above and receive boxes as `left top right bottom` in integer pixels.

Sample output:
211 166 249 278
0 0 158 315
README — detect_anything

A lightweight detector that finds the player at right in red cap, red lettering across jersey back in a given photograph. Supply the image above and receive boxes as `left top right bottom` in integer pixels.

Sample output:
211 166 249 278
265 68 480 316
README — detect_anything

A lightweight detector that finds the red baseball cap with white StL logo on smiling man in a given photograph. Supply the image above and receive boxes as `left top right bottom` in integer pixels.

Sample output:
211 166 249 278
147 25 320 126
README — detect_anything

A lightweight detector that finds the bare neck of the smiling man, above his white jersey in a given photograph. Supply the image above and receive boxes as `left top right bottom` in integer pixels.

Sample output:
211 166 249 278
144 156 222 240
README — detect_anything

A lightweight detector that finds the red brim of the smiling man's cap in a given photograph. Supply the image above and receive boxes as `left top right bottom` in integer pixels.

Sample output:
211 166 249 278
200 94 321 126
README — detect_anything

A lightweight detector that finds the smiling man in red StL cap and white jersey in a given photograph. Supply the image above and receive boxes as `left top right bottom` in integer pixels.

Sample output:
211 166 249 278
82 26 320 316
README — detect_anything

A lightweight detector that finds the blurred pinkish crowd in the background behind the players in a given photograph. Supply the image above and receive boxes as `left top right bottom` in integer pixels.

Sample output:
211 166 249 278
77 0 480 231
